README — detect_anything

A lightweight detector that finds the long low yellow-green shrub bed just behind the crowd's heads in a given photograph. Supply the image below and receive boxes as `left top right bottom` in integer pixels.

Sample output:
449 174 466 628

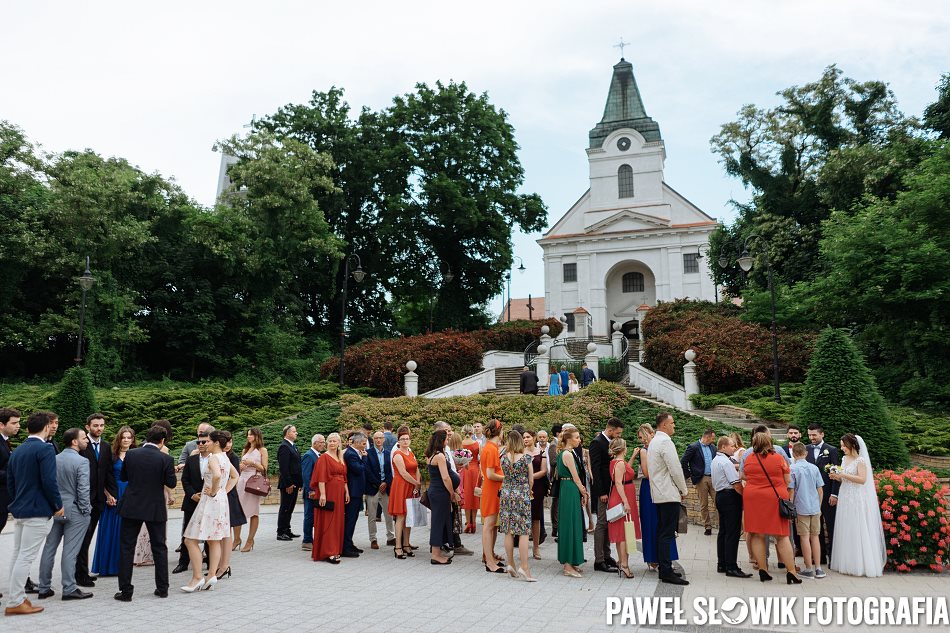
340 382 629 462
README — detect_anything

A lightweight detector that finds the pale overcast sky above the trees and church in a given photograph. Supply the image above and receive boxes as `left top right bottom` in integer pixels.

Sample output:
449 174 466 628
0 0 950 310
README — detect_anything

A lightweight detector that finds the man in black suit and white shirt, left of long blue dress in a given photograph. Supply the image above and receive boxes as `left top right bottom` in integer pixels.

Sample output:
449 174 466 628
76 413 119 587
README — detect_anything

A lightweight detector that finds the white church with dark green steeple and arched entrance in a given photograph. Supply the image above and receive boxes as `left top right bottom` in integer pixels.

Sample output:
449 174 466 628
538 58 717 338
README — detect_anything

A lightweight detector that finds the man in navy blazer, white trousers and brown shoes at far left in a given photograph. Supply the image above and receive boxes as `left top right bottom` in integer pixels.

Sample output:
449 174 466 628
4 413 64 615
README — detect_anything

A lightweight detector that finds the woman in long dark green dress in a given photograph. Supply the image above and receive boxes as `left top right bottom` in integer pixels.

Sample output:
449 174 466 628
557 428 587 578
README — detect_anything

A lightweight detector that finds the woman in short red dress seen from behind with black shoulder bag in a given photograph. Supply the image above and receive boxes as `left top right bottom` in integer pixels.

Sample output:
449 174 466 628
742 433 801 584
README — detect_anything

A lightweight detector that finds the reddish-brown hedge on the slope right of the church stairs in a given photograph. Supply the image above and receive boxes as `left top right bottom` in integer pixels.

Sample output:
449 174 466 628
643 300 815 393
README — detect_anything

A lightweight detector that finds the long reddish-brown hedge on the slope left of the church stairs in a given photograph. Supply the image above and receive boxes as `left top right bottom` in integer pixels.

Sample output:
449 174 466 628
320 319 562 397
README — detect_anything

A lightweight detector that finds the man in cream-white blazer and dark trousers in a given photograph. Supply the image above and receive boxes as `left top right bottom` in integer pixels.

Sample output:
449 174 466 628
647 411 689 585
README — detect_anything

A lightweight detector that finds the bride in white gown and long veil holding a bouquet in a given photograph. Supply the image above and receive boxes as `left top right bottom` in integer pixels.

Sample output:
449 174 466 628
829 433 887 577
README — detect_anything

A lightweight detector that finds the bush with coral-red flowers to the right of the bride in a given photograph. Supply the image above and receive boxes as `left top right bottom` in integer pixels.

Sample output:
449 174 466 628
874 468 950 572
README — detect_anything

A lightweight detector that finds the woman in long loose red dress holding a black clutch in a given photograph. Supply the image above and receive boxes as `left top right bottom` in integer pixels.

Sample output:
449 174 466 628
310 433 350 565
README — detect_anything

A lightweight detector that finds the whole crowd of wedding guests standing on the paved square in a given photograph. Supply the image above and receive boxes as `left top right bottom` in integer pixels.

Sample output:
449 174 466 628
0 402 884 615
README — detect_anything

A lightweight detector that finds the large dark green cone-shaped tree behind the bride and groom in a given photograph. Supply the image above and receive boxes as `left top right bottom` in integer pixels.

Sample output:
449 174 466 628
795 328 910 468
